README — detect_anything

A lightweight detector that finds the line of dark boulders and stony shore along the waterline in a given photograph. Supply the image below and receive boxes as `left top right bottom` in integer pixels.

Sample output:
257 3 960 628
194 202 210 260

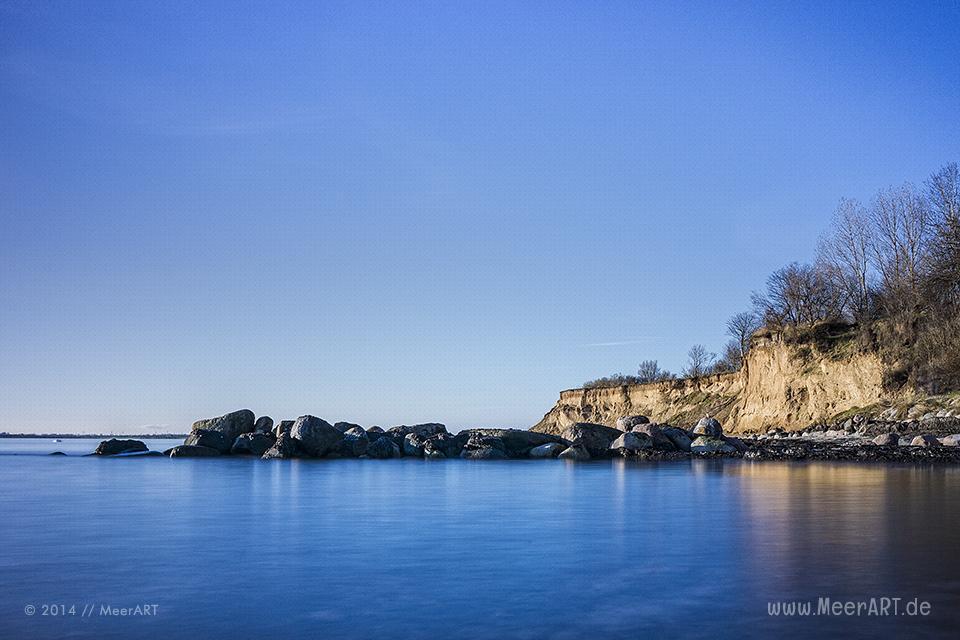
96 409 960 463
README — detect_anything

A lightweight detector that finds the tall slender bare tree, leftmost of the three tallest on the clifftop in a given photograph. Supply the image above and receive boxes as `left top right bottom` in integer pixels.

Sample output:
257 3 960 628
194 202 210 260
818 198 874 322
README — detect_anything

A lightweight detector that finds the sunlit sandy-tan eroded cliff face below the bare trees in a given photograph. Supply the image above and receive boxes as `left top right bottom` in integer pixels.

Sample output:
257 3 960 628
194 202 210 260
533 336 889 434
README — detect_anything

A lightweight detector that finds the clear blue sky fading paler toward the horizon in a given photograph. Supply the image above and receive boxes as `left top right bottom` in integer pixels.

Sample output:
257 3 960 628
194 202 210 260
0 0 960 433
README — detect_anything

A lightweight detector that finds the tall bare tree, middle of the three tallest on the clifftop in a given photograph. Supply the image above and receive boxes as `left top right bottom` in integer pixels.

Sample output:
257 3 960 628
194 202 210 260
870 184 934 310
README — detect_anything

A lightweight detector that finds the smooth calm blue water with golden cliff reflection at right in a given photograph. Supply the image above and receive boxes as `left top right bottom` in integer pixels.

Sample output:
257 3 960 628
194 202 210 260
0 440 960 640
